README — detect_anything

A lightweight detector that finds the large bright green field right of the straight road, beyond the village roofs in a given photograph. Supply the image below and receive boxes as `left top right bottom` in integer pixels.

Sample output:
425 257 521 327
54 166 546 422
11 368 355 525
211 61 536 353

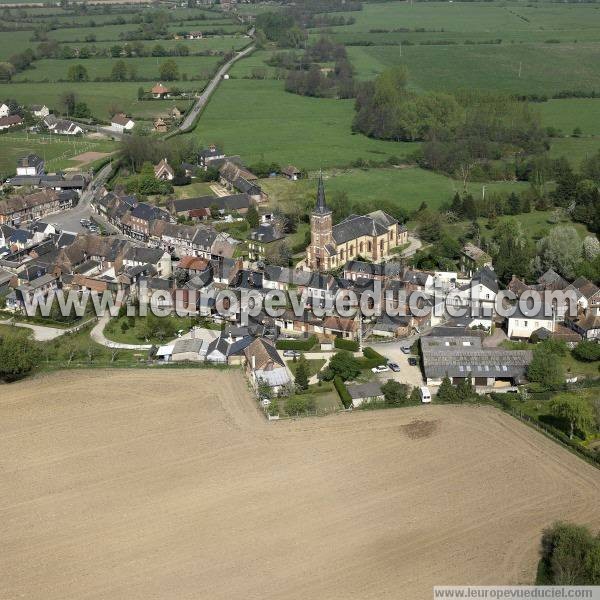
184 79 414 169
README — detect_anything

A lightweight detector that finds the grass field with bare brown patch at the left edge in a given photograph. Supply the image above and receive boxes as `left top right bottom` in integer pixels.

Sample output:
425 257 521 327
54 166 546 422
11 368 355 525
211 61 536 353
0 132 117 174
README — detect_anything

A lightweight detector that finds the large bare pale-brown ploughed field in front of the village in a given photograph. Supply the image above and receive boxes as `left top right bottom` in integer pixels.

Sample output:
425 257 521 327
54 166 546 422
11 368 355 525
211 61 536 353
0 370 600 600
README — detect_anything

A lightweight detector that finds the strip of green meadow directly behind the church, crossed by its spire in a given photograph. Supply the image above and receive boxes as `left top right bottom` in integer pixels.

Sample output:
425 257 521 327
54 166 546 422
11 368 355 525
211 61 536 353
261 168 525 211
